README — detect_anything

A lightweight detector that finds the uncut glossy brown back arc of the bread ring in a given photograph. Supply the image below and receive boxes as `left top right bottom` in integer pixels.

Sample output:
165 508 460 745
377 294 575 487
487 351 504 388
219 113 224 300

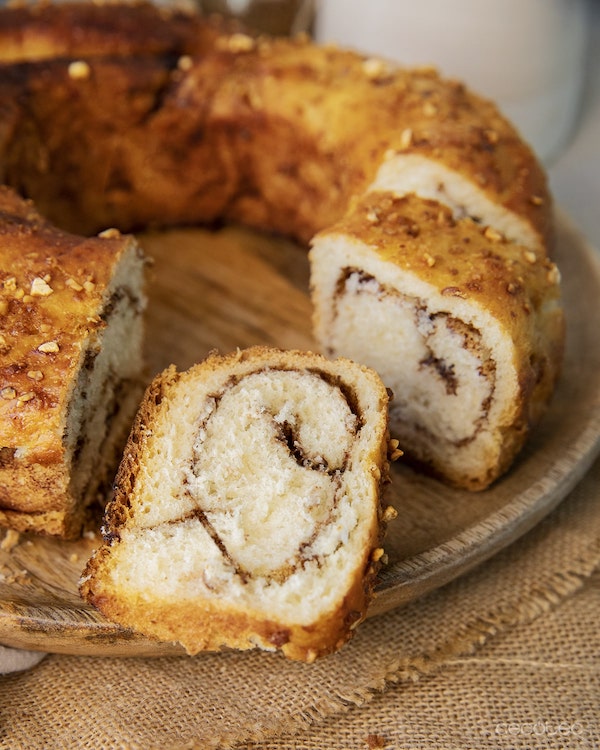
0 3 552 253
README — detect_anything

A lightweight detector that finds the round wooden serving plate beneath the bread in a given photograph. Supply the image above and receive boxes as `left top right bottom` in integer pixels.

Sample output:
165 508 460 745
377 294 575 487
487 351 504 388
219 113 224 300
0 216 600 656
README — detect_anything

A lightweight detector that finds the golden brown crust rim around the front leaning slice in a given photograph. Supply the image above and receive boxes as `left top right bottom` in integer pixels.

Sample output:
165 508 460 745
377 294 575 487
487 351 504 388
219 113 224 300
80 347 389 661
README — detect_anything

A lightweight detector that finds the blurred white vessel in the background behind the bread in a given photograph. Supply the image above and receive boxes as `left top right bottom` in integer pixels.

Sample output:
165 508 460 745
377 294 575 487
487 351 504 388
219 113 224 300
314 0 589 164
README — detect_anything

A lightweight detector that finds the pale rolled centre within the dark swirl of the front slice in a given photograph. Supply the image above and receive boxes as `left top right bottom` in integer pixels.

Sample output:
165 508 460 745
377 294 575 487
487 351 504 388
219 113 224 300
180 368 363 587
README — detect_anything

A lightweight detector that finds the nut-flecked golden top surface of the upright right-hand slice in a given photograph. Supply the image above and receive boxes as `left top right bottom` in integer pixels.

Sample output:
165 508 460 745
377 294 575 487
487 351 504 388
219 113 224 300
324 192 560 320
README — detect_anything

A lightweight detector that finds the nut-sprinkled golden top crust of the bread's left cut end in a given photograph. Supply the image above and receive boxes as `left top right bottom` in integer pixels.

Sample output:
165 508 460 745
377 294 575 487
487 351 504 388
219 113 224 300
0 187 137 463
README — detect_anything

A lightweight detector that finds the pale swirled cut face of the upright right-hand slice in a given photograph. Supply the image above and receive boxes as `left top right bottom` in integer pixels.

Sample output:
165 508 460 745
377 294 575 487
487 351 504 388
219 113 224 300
311 235 518 490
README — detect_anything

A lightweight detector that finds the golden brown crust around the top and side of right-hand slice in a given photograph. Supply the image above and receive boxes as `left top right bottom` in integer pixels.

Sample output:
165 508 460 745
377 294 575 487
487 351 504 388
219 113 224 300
316 192 564 490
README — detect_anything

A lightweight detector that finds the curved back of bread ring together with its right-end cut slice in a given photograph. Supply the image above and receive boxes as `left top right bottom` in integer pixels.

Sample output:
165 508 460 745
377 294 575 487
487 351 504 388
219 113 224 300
0 3 564 516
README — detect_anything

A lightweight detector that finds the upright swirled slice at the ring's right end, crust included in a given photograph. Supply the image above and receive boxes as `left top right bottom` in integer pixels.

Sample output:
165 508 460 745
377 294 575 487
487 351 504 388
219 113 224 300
310 191 564 490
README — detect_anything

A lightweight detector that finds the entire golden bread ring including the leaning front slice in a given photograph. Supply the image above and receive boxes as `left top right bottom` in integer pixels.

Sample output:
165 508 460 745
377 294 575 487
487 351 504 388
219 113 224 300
0 3 564 661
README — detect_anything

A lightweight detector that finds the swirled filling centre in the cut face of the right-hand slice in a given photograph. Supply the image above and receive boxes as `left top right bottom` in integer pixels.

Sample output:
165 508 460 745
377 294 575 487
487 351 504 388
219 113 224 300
330 267 496 448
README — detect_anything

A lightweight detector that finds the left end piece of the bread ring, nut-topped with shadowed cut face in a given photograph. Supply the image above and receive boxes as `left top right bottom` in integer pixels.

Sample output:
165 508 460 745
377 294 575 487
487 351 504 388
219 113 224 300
0 188 145 538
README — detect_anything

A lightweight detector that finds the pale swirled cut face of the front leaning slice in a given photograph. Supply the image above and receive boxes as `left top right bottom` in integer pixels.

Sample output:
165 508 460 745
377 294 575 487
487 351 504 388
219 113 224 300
103 368 383 624
